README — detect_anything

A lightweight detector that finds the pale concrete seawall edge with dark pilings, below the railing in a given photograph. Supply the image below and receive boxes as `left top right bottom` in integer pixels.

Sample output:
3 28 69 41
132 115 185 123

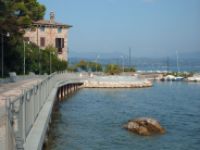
24 81 82 150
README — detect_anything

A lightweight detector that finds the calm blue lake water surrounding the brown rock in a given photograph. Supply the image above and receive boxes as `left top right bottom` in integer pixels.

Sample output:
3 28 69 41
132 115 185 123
47 82 200 150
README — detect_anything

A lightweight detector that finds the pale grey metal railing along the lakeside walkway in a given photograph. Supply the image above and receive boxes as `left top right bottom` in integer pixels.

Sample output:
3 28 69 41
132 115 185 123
6 72 73 149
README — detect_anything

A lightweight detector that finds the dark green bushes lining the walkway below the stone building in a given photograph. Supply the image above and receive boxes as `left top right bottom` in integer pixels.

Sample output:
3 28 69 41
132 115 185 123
0 42 67 75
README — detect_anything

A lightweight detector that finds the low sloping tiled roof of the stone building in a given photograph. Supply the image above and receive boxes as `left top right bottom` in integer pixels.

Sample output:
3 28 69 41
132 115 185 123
33 20 72 28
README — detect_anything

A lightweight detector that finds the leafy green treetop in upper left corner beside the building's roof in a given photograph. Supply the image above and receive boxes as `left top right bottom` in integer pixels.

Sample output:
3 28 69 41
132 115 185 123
0 0 45 45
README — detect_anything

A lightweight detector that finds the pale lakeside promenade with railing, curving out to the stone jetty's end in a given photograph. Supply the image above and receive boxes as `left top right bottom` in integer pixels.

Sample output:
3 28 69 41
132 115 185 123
0 72 152 150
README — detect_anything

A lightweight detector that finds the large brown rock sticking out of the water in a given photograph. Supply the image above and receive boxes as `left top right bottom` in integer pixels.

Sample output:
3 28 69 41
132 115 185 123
124 118 165 136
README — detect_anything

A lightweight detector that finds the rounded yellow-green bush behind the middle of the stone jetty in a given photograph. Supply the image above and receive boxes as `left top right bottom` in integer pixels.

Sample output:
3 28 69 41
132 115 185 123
105 64 122 75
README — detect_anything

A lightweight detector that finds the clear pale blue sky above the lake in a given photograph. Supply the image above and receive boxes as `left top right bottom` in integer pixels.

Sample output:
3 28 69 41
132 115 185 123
38 0 200 57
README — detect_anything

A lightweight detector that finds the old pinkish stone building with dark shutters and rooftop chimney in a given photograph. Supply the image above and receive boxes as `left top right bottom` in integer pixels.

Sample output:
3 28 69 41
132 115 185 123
24 12 72 61
